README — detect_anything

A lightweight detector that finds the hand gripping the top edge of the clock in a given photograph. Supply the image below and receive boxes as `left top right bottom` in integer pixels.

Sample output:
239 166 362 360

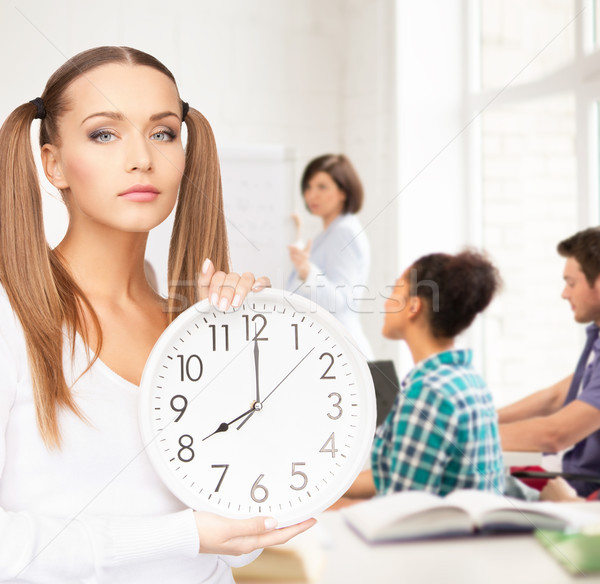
198 258 271 312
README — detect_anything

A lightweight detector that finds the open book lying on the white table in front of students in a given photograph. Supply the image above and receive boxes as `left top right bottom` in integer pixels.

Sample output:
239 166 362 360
341 489 597 542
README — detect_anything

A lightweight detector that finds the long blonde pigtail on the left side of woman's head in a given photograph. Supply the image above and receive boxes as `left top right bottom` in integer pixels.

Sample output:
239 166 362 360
0 103 84 447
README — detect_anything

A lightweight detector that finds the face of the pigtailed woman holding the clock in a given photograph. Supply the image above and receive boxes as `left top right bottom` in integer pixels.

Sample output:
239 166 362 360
42 63 185 232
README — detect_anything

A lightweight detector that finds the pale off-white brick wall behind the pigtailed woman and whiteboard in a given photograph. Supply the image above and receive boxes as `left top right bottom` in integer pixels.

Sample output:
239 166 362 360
0 0 397 356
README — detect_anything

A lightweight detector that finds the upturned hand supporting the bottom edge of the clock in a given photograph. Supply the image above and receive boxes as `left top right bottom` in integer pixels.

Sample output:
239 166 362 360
194 511 316 556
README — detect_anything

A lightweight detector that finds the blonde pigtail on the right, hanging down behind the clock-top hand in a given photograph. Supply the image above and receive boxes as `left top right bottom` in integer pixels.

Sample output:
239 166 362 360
168 108 229 319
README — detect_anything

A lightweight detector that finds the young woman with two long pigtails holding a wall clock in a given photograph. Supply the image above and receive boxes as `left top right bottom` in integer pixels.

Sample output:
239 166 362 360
0 47 313 584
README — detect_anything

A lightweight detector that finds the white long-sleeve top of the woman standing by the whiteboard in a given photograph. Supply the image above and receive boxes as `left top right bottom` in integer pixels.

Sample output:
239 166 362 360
286 213 373 359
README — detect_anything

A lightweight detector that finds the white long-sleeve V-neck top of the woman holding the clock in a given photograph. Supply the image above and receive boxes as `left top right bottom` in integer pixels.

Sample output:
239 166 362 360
0 289 256 584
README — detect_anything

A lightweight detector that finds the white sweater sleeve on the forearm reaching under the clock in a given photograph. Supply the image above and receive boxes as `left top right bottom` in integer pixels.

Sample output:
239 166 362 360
0 510 198 582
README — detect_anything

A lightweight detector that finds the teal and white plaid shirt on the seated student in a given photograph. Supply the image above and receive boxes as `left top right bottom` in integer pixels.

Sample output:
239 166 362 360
371 350 504 496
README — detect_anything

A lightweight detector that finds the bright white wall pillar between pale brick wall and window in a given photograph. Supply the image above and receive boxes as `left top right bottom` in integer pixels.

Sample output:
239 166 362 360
386 0 475 371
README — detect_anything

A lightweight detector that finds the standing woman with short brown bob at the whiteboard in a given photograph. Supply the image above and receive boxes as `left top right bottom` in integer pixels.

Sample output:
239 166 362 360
287 154 373 359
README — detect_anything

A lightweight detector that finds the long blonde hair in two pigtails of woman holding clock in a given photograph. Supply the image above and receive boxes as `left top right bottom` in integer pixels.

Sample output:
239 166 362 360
0 47 229 448
